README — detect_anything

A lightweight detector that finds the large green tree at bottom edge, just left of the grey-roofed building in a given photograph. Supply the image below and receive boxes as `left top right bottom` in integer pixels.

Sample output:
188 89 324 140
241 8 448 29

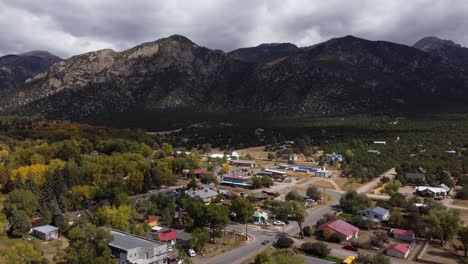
63 223 114 264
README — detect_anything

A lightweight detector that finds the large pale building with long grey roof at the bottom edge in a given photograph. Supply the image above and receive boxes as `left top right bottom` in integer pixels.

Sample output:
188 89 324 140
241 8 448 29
108 229 168 264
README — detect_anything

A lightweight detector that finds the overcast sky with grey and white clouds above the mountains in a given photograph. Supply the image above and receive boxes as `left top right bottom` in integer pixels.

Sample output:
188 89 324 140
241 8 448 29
0 0 468 58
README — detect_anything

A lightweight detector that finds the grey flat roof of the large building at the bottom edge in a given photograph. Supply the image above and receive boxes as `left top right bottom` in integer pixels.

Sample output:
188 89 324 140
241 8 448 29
109 229 166 251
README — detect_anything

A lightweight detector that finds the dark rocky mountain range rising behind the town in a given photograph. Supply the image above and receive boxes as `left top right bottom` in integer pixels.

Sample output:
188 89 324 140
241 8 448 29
0 35 468 127
